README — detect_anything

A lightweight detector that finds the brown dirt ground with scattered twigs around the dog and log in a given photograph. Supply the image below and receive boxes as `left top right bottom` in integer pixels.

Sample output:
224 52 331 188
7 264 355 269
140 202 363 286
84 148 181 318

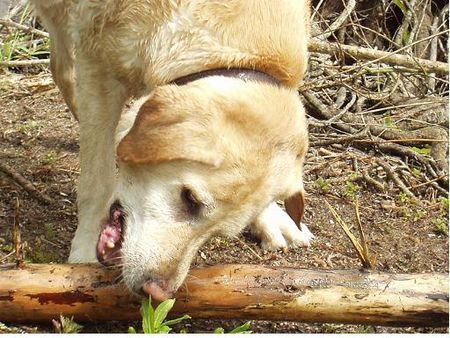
0 73 449 333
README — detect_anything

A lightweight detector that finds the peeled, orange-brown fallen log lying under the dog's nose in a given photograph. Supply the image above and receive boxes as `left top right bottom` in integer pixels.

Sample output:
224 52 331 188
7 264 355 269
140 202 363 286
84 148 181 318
0 264 449 327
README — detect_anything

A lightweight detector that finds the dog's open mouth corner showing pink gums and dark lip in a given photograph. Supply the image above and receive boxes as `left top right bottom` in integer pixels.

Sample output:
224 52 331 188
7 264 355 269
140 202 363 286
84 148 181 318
97 201 125 266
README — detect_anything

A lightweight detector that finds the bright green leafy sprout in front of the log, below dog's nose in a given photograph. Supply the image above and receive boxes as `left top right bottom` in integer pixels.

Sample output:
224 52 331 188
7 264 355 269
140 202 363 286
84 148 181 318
128 296 191 333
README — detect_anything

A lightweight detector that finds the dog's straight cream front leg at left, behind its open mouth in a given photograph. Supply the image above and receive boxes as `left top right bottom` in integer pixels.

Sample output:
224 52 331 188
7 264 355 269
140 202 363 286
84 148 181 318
69 62 125 263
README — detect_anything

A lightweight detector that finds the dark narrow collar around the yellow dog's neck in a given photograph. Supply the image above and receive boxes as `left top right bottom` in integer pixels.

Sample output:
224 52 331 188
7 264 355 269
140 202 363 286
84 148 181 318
171 68 281 86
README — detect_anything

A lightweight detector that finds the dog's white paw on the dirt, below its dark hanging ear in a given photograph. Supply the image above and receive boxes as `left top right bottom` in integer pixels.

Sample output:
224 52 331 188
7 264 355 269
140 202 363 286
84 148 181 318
251 203 314 250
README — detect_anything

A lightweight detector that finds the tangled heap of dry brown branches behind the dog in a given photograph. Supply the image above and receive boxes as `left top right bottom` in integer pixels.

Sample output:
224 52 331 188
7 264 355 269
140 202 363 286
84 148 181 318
300 0 449 200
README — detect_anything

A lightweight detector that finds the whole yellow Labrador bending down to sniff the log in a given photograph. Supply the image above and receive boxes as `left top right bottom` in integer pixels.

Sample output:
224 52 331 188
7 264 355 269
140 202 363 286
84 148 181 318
30 0 312 301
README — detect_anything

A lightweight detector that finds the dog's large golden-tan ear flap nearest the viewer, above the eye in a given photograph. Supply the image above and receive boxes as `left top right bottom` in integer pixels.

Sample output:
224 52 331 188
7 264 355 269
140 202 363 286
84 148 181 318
117 92 220 166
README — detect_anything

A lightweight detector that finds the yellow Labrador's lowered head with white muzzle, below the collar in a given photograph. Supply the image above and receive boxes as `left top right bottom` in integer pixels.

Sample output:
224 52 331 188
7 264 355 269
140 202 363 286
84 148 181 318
98 77 308 300
